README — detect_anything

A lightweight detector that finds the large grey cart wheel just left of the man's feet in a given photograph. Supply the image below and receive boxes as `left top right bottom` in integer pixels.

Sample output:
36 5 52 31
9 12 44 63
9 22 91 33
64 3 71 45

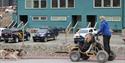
97 50 109 63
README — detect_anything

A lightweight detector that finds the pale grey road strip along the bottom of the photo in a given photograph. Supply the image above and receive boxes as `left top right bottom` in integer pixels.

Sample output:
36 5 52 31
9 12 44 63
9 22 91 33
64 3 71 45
0 59 125 63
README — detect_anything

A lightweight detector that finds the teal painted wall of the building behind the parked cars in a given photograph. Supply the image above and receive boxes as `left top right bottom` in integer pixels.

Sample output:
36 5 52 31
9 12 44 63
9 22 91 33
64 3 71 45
17 0 125 29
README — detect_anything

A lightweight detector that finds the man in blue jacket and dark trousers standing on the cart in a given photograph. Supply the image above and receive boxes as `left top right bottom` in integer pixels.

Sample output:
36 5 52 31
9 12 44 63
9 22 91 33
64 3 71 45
97 16 111 58
